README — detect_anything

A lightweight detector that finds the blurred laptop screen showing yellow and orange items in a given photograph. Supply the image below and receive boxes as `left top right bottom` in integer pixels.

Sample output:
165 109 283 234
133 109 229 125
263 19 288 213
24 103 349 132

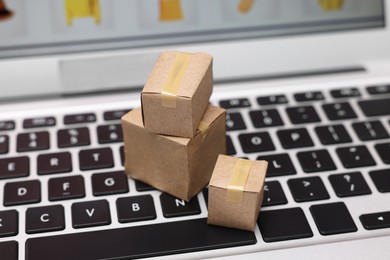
0 0 385 58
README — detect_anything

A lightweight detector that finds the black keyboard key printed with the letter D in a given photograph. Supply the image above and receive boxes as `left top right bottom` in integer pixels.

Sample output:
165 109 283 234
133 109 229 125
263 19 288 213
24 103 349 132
4 180 41 206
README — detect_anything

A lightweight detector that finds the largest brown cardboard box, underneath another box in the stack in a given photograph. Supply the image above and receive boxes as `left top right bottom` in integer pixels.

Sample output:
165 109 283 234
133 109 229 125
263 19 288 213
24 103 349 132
122 105 226 201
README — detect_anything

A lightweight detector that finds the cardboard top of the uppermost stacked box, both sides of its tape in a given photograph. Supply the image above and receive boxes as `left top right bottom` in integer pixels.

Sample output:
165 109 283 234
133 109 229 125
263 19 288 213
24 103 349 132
142 51 213 99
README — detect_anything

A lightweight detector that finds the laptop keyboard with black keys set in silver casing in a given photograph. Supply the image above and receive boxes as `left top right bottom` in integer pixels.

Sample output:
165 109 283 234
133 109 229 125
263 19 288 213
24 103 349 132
0 85 390 259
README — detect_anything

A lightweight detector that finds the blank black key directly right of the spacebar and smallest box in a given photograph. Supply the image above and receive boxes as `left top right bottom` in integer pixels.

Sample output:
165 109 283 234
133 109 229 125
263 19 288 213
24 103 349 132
258 208 313 243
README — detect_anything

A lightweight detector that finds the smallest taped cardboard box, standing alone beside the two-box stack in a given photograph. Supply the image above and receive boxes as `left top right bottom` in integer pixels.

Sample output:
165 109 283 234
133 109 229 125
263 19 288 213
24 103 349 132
207 155 268 231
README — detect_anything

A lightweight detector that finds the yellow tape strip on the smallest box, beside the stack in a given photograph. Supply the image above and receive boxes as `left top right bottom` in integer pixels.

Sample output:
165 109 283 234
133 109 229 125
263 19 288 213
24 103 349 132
226 159 252 202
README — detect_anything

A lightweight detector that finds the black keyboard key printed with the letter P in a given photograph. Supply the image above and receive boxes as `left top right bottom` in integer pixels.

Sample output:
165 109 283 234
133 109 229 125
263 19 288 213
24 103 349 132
277 128 314 149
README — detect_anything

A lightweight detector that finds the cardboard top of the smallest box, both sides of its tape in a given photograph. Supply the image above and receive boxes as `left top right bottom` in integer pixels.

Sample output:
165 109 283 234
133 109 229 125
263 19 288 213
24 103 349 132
209 155 268 192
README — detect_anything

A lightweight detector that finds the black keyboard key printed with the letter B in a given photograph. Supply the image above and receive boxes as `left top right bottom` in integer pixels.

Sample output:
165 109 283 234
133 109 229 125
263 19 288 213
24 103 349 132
116 195 157 223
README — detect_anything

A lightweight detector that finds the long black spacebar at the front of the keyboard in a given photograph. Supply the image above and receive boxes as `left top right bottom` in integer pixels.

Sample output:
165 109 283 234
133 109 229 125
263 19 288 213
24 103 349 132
26 219 256 260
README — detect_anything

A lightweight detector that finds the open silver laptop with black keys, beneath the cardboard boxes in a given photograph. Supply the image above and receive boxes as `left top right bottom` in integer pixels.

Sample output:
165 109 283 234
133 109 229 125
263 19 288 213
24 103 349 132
0 0 390 260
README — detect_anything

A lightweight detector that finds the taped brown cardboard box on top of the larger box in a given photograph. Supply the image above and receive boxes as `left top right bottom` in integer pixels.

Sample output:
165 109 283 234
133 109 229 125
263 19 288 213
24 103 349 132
141 51 213 137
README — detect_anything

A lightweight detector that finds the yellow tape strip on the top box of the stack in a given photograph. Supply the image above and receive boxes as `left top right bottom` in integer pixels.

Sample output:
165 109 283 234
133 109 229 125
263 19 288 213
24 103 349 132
161 52 191 108
